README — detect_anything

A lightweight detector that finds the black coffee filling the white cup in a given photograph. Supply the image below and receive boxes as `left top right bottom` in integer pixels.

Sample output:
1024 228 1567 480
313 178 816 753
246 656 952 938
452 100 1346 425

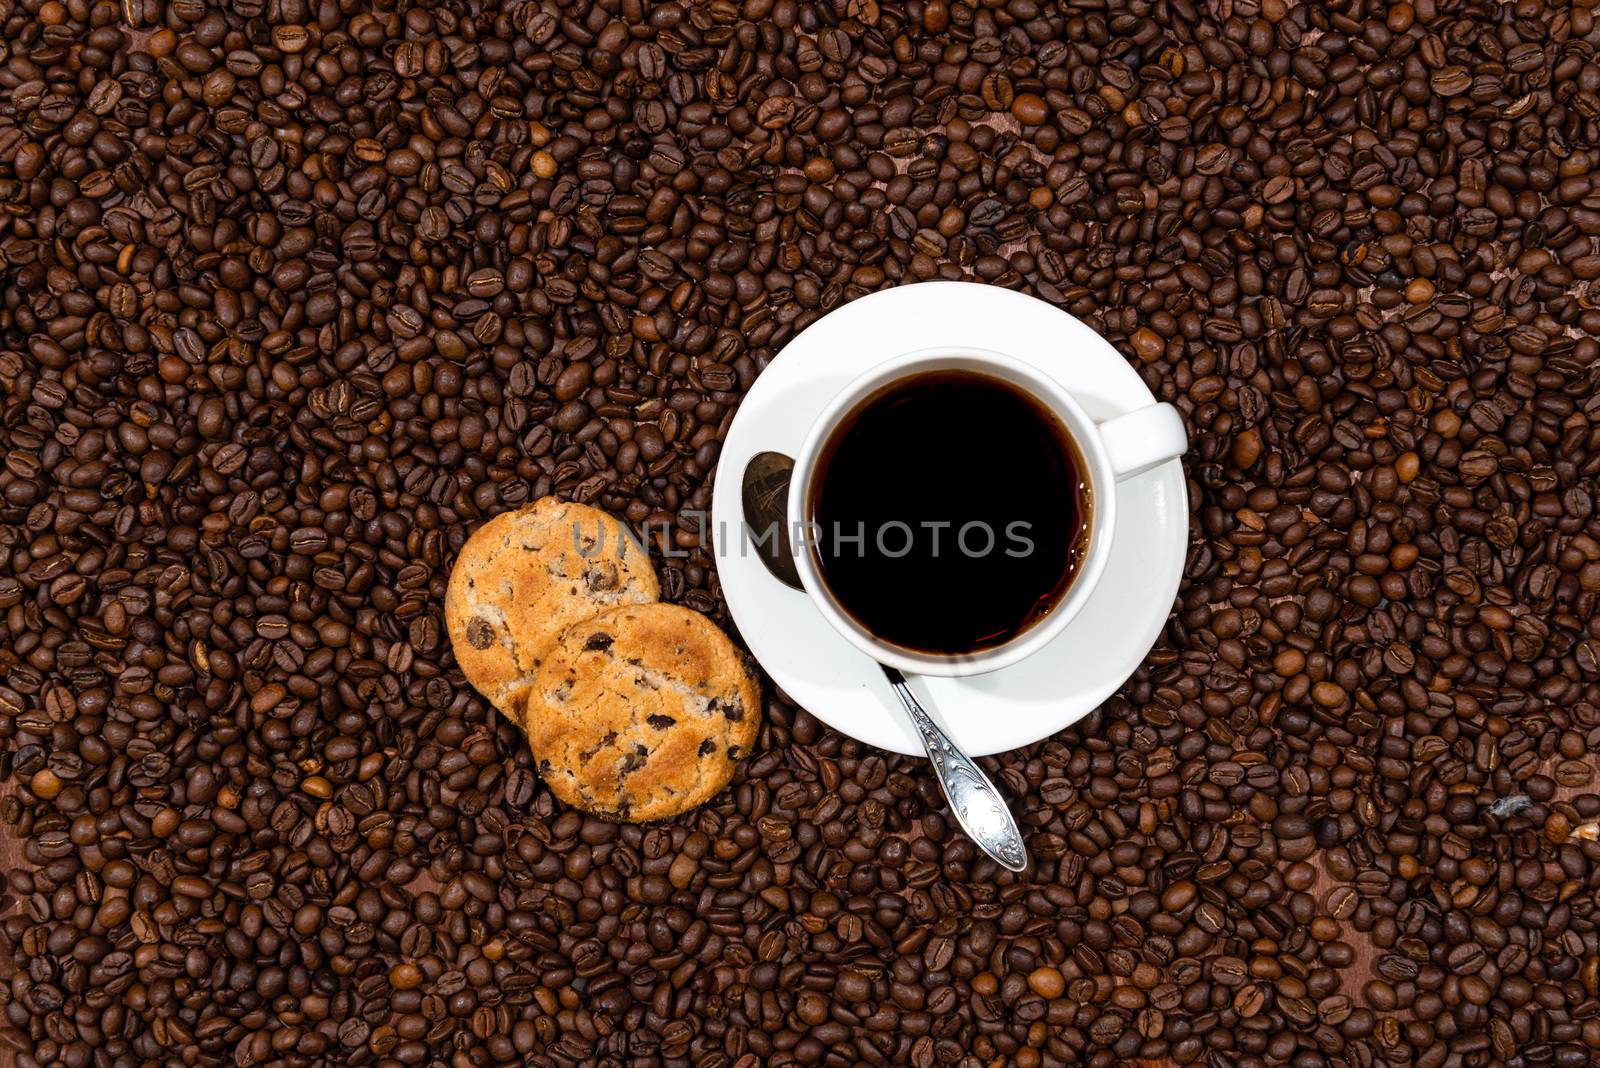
806 371 1090 656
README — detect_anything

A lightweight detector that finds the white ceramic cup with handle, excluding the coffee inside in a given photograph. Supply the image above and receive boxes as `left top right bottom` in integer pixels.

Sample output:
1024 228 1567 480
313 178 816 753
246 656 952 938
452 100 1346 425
789 347 1189 676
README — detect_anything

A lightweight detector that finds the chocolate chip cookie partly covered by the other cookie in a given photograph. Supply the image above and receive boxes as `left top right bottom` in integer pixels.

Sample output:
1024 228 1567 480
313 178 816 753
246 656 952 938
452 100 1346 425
445 497 661 719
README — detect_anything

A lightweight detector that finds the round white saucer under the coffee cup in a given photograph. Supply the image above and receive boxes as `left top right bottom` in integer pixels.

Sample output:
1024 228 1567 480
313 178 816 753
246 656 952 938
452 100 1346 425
712 281 1189 756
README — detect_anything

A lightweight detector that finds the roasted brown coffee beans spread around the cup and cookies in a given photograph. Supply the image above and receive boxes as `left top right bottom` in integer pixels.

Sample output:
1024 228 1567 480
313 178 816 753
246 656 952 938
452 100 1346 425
0 0 1600 1068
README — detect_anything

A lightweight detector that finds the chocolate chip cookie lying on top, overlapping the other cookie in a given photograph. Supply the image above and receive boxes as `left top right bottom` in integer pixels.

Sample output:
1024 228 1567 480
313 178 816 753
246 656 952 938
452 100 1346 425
522 604 762 822
